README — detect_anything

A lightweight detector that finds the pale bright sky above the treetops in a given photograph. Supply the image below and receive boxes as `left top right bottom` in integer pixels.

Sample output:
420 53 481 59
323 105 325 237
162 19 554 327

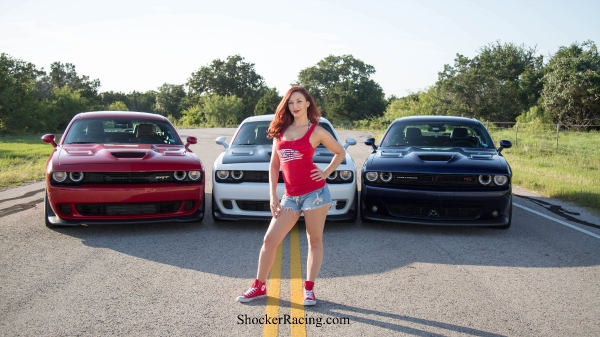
0 0 600 97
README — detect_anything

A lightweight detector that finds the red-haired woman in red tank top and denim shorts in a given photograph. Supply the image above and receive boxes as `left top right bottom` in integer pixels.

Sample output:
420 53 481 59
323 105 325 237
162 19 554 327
236 87 345 305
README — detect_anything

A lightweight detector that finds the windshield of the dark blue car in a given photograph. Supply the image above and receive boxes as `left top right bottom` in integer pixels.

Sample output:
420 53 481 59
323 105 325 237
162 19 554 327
381 123 494 149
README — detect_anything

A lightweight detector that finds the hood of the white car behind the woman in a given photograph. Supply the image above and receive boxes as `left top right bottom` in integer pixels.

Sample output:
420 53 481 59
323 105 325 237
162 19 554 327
223 145 346 164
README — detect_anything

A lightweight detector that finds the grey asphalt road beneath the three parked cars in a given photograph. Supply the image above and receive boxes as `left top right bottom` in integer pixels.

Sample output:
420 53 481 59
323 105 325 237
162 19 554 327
0 129 600 336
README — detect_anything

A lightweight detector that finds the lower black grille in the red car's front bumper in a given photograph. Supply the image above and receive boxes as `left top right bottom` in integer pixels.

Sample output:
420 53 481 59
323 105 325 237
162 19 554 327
75 201 181 215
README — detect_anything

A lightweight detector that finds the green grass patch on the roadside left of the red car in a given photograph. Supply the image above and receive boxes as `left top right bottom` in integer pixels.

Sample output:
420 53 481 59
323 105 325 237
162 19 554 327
0 135 53 187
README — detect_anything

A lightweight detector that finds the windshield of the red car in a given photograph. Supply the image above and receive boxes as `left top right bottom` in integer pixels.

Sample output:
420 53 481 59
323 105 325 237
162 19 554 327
64 118 182 145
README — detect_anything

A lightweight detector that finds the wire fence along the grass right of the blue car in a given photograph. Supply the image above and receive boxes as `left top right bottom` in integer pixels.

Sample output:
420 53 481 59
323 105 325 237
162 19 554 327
484 122 600 159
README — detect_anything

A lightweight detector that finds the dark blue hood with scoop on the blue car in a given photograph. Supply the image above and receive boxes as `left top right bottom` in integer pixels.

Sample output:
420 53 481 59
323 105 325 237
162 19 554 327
365 148 508 174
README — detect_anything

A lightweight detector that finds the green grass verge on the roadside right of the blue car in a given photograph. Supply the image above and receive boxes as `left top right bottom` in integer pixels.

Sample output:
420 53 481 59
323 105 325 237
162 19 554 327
490 129 600 213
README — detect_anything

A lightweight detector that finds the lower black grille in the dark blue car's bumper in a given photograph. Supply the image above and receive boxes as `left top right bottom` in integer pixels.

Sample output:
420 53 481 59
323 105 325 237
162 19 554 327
387 203 482 220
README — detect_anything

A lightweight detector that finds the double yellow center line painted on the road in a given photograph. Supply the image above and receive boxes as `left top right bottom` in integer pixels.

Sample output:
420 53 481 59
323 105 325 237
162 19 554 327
263 225 306 337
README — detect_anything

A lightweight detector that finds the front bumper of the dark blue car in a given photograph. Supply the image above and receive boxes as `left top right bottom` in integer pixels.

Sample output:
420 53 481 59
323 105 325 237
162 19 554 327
361 184 512 226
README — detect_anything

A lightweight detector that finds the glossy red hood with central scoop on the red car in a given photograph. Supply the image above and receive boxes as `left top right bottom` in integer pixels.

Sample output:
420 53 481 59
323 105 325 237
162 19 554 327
55 144 200 170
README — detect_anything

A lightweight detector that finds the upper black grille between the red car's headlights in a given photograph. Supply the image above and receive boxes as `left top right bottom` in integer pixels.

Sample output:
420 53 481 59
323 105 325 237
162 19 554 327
82 171 175 184
